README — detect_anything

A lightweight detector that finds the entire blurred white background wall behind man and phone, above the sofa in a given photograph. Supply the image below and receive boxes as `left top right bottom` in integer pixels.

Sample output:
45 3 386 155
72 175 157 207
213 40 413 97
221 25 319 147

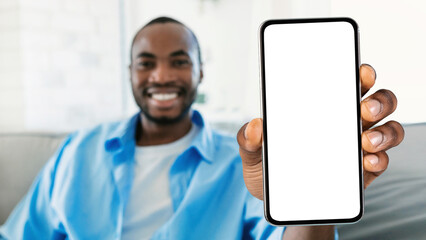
0 0 426 132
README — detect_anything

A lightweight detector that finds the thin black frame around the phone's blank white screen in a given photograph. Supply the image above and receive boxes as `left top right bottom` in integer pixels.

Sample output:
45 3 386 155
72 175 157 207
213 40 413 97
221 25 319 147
259 17 364 226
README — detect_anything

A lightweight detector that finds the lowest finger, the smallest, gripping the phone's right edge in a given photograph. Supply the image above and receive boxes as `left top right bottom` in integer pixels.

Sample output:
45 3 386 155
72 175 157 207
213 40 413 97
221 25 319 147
364 151 389 188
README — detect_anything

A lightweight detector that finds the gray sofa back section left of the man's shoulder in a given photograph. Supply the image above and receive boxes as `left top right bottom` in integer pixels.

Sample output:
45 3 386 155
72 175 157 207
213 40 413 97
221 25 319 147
0 133 66 225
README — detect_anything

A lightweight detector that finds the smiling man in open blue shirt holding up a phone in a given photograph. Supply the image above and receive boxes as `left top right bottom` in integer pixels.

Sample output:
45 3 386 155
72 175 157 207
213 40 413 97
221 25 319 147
0 17 403 239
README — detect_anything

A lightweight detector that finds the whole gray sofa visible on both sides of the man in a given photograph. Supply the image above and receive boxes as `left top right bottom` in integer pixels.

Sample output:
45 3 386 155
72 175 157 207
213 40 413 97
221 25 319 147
0 123 426 239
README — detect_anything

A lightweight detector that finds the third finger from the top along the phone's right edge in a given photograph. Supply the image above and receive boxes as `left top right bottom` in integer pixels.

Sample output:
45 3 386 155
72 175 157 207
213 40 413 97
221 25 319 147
361 121 405 153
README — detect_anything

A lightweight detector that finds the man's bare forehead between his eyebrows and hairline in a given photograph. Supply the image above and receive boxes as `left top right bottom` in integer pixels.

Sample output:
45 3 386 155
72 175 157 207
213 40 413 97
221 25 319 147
133 23 195 54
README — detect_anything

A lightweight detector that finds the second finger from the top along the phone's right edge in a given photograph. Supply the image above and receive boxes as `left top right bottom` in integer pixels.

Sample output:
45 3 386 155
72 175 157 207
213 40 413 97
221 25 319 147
361 89 398 130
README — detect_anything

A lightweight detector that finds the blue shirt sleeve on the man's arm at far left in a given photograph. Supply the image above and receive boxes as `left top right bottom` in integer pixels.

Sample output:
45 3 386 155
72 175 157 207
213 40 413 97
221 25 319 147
0 136 71 239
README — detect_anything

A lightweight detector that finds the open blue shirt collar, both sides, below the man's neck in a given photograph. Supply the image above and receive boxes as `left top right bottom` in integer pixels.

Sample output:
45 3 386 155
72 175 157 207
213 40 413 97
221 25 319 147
104 110 215 162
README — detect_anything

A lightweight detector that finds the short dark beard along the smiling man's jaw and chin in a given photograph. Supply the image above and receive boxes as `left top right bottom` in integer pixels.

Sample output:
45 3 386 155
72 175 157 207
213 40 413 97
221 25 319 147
133 85 197 125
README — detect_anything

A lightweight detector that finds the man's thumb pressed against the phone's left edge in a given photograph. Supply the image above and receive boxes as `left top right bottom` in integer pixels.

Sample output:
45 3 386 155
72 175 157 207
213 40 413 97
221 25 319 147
237 118 263 166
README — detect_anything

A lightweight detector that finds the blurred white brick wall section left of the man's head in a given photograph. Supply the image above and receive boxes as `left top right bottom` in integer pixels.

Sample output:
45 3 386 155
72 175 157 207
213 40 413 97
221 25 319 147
0 0 123 131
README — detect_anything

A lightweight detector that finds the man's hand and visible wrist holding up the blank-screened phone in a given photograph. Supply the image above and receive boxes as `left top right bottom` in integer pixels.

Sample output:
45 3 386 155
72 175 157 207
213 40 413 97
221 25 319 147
237 64 404 239
